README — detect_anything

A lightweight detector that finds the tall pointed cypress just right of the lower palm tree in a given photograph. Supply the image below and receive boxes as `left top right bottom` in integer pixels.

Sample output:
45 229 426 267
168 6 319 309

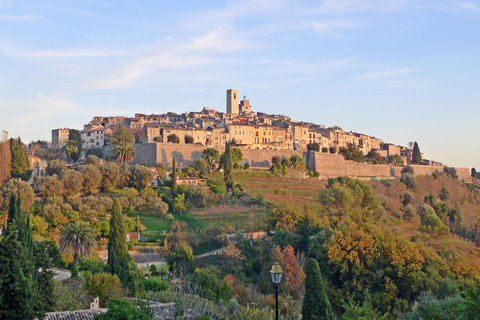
106 198 138 293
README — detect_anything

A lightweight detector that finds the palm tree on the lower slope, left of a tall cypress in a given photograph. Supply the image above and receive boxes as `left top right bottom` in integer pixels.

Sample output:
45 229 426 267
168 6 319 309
60 221 96 264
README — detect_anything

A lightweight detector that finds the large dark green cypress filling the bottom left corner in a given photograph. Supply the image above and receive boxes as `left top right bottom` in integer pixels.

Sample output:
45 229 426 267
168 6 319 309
0 193 53 319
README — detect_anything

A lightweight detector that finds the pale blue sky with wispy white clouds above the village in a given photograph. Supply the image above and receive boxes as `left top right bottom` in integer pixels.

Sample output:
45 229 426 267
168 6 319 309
0 0 480 170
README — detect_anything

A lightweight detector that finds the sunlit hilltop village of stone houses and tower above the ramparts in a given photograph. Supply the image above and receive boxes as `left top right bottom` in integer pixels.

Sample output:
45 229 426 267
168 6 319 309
52 89 441 165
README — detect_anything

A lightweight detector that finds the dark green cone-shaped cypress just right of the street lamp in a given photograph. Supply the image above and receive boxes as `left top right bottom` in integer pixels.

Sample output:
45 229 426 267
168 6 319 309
302 258 334 320
